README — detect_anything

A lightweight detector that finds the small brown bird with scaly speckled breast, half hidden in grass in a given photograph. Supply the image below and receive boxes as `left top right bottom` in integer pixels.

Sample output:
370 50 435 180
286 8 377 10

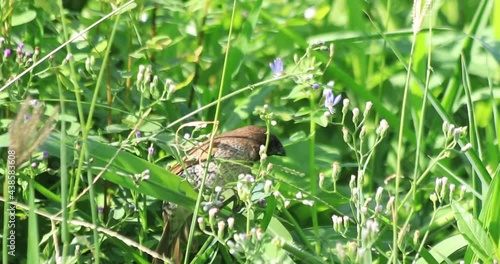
153 126 286 264
